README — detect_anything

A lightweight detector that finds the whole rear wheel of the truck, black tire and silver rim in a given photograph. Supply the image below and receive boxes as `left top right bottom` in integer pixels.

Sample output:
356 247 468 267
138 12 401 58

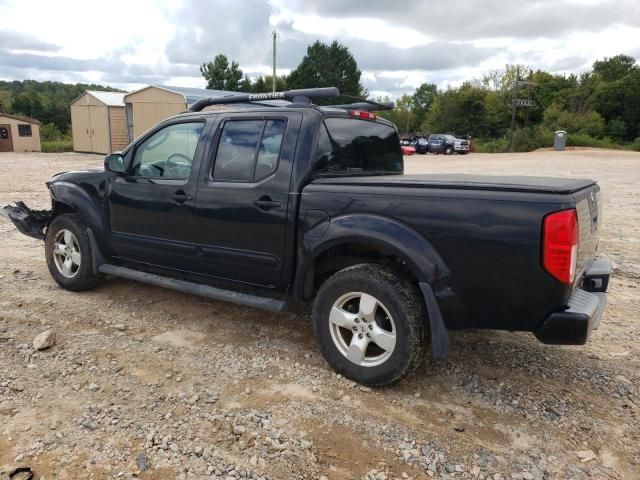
313 264 427 387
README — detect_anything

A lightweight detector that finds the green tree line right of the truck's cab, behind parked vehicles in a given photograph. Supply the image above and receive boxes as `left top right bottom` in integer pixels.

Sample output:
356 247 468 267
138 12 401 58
382 55 640 151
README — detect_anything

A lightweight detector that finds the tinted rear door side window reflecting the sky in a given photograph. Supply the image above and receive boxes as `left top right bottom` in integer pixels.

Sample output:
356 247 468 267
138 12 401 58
213 119 287 182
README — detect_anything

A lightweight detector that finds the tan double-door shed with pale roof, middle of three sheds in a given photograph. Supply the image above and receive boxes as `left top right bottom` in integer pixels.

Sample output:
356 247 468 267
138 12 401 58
71 90 129 153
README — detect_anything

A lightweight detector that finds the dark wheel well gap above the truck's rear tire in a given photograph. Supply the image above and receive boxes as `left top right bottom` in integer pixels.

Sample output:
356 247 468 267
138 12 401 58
303 242 418 300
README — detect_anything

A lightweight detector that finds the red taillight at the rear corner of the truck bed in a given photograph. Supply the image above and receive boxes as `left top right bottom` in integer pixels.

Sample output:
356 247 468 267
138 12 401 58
542 208 578 283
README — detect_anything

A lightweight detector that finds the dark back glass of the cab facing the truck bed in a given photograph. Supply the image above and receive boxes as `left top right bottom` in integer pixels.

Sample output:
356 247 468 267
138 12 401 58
315 118 403 175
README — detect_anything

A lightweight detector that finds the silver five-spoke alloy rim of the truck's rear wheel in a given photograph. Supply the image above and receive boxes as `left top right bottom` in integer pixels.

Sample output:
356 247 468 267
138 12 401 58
329 292 396 367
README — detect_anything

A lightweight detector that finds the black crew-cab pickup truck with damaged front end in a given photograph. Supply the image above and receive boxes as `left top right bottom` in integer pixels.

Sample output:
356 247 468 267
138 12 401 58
3 88 611 386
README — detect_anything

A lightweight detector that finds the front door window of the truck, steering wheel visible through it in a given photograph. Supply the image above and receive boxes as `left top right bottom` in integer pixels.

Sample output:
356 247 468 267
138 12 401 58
131 122 204 180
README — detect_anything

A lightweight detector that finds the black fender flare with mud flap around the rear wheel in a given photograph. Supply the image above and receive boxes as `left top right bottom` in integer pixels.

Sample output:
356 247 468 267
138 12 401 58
294 213 452 358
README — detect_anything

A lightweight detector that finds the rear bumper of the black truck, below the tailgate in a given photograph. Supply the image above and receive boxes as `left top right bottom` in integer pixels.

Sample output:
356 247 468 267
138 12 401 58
533 259 611 345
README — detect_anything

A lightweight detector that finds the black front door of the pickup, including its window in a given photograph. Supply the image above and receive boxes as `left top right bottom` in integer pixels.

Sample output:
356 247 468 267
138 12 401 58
107 120 205 270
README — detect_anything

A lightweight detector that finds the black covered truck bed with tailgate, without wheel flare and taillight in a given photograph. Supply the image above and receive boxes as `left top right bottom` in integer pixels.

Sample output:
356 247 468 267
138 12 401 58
301 174 601 331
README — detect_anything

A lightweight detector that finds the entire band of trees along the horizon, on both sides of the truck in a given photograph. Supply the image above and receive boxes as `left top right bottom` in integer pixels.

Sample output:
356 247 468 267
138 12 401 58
0 41 640 151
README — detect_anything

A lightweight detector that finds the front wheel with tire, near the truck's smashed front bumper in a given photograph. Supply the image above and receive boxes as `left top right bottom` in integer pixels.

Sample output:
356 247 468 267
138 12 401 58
44 213 103 292
